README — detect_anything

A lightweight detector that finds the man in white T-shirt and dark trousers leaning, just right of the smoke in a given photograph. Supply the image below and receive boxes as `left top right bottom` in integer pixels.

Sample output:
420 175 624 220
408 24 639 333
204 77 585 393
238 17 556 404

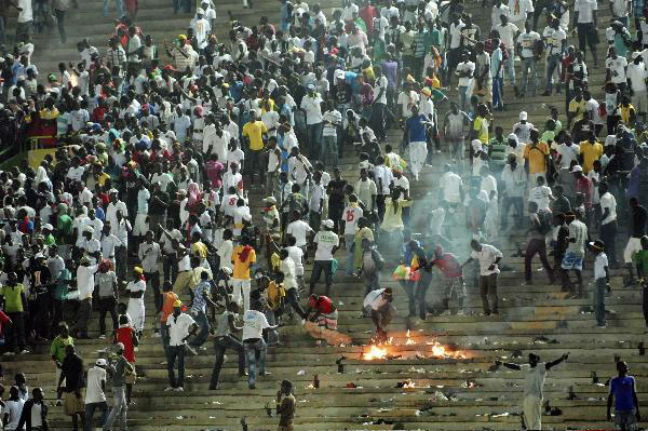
462 239 504 316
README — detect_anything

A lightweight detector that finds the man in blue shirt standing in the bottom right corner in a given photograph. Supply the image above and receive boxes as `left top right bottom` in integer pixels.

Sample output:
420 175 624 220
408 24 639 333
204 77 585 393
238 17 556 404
607 361 641 431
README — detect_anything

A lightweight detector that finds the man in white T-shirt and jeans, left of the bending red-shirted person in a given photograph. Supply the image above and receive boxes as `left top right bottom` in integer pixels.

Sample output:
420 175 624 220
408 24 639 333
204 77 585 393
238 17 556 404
242 298 277 389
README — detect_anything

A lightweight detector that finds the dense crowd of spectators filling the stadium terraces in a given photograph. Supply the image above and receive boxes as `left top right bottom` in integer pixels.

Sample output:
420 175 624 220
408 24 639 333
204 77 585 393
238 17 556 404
0 0 648 431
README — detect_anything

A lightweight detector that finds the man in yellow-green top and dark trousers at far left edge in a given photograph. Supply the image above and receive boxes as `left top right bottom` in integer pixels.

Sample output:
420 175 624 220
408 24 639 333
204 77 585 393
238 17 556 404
0 271 29 354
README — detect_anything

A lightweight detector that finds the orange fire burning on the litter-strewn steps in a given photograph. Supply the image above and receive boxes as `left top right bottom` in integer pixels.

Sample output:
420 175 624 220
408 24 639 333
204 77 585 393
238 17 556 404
360 330 468 361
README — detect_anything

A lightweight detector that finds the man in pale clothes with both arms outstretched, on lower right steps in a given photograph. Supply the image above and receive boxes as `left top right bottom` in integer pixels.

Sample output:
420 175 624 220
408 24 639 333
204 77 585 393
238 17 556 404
495 353 569 430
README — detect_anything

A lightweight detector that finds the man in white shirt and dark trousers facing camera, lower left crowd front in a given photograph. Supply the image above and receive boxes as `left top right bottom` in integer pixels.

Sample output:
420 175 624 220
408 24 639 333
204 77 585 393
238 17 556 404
164 299 198 392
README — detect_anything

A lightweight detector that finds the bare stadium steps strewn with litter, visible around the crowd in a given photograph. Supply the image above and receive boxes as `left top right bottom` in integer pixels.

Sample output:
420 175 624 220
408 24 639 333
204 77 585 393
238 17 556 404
4 0 648 431
